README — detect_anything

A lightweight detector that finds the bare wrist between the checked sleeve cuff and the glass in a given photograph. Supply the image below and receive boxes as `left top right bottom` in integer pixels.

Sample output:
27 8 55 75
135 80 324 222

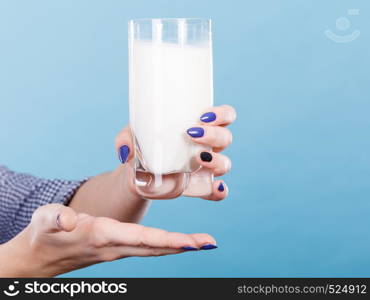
69 164 150 223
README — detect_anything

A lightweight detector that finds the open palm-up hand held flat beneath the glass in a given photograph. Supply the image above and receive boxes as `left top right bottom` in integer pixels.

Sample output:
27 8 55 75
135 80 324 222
0 204 216 277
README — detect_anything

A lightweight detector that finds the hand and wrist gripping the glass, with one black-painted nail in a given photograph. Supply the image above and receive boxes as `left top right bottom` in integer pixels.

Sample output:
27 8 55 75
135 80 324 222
68 105 236 223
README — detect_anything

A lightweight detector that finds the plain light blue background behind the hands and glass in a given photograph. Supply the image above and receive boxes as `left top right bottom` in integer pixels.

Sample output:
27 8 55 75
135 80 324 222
0 0 370 277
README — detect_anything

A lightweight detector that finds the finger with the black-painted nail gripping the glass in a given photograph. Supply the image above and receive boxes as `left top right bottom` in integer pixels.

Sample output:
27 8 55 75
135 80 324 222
196 151 231 176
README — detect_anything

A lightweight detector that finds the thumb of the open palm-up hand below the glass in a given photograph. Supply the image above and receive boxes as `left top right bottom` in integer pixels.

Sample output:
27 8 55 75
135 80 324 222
31 203 77 233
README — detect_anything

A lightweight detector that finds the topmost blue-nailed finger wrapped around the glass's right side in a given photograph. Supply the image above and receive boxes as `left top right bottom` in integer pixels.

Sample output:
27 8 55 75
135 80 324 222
200 105 236 126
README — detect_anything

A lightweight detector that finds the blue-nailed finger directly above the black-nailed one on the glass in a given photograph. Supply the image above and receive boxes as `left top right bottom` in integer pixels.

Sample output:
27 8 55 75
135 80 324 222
187 125 233 152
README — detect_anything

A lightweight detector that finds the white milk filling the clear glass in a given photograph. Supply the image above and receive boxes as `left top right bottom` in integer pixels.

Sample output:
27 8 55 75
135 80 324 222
129 41 213 174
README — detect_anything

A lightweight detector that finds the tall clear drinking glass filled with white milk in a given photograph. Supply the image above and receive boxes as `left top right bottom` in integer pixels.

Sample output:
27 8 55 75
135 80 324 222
129 18 213 199
